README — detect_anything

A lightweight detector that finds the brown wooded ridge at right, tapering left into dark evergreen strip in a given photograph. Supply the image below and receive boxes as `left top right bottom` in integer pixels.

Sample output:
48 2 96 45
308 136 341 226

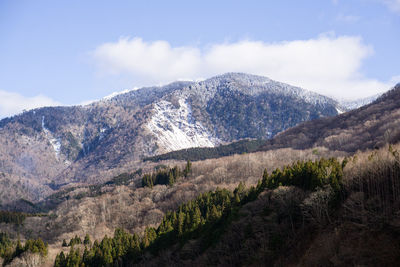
145 84 400 162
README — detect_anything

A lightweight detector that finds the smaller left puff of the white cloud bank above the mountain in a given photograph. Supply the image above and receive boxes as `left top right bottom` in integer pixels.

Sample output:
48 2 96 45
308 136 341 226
94 38 201 81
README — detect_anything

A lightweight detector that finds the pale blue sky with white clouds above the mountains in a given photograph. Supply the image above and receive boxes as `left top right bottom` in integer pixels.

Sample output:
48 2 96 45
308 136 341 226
0 0 400 118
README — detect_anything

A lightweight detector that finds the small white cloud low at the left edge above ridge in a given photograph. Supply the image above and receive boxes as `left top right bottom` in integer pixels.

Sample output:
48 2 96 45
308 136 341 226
0 90 60 118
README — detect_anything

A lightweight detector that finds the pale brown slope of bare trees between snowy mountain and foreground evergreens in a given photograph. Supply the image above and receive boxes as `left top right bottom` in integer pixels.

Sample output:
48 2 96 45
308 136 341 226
0 149 344 266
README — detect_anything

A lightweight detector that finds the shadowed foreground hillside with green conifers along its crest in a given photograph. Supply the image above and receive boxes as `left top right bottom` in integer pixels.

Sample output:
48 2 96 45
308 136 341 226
55 146 400 266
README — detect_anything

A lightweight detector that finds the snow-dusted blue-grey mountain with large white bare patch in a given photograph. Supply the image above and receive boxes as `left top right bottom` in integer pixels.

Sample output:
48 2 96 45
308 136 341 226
0 73 343 204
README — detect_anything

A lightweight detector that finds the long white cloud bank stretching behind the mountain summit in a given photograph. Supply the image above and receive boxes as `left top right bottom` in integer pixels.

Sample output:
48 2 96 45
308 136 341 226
93 34 392 98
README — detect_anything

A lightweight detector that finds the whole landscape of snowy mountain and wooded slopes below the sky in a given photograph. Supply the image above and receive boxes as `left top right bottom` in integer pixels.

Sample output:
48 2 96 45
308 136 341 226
0 73 400 266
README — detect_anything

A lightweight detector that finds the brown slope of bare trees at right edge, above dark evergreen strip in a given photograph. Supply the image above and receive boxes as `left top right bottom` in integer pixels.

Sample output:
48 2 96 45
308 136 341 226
261 84 400 152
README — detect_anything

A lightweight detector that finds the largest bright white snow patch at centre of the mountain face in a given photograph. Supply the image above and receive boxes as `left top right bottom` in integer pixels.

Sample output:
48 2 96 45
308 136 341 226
146 98 221 152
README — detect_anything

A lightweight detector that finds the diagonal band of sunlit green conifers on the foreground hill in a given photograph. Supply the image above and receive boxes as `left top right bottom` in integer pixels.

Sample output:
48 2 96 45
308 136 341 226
55 159 346 266
